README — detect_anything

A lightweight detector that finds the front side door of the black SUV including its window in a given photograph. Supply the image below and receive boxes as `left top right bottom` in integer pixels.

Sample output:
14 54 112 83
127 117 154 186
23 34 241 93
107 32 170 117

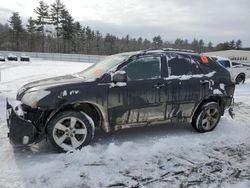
109 55 165 125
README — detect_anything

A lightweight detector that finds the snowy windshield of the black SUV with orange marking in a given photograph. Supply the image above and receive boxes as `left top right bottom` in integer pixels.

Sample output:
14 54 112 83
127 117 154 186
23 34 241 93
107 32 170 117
77 54 129 80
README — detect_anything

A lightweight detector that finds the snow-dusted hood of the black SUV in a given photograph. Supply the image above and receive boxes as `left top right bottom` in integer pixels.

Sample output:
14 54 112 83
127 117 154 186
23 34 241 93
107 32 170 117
16 75 86 100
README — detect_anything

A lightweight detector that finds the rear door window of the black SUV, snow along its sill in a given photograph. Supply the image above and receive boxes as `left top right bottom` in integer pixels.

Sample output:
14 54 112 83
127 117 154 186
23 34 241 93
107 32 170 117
168 56 202 76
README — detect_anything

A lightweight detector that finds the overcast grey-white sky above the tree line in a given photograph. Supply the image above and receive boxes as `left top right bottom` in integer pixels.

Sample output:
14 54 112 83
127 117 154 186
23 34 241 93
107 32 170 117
0 0 250 47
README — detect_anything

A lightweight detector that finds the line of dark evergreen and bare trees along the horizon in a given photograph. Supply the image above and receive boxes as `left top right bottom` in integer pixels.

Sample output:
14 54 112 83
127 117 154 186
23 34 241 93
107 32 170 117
0 0 242 55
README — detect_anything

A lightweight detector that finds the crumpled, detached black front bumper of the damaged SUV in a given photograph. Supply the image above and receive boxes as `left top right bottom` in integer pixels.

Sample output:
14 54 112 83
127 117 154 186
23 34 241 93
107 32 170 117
6 100 37 146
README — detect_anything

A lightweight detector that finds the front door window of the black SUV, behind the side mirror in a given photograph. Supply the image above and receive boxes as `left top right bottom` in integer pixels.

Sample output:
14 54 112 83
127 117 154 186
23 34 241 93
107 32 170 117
122 56 161 80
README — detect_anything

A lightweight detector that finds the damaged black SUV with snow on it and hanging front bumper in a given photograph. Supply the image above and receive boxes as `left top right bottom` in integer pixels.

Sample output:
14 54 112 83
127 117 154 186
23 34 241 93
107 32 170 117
7 50 235 151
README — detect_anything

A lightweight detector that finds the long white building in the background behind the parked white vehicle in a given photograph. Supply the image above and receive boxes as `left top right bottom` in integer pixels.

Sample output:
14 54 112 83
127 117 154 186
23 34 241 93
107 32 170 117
204 50 250 63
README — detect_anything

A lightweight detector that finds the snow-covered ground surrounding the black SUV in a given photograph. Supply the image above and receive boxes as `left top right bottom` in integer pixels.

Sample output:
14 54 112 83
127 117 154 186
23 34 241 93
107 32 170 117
0 60 250 188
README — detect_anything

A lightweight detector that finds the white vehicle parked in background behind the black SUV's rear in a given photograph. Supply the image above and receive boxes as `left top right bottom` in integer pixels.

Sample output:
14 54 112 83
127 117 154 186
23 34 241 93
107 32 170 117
212 56 250 84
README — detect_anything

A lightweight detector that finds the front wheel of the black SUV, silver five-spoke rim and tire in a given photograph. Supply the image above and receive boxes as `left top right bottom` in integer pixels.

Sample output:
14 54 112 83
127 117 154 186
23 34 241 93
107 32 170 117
46 111 94 151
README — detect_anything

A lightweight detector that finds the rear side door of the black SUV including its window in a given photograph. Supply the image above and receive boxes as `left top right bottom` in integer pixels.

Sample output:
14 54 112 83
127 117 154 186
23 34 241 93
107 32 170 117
165 54 205 120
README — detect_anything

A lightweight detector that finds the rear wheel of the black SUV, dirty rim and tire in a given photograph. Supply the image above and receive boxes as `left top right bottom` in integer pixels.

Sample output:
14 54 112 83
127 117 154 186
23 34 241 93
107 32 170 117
191 102 221 133
